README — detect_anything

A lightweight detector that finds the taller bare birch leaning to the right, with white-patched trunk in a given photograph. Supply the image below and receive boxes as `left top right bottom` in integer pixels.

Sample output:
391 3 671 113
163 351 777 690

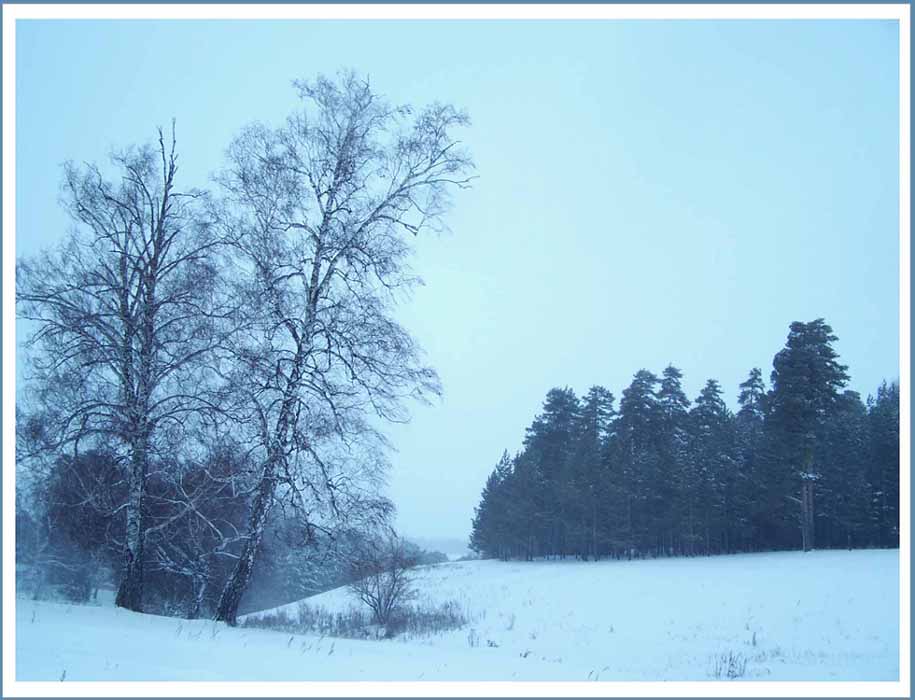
216 73 473 624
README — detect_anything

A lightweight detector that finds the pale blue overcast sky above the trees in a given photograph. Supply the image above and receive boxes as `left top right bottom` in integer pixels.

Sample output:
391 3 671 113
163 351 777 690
16 21 899 539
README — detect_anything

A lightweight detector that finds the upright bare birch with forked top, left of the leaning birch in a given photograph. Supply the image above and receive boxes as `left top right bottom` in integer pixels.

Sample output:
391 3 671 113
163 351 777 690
16 125 225 611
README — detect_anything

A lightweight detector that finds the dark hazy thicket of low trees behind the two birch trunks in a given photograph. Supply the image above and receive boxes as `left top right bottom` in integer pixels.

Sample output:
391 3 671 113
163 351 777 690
16 438 447 618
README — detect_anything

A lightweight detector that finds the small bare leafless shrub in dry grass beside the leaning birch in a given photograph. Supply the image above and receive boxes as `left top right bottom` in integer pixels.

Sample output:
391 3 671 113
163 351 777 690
349 532 417 625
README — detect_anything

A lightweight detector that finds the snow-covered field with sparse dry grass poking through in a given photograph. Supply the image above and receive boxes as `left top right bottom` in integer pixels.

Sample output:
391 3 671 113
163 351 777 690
16 550 899 681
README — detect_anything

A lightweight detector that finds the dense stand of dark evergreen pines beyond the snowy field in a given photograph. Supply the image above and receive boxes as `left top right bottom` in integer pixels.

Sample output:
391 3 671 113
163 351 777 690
471 319 899 559
